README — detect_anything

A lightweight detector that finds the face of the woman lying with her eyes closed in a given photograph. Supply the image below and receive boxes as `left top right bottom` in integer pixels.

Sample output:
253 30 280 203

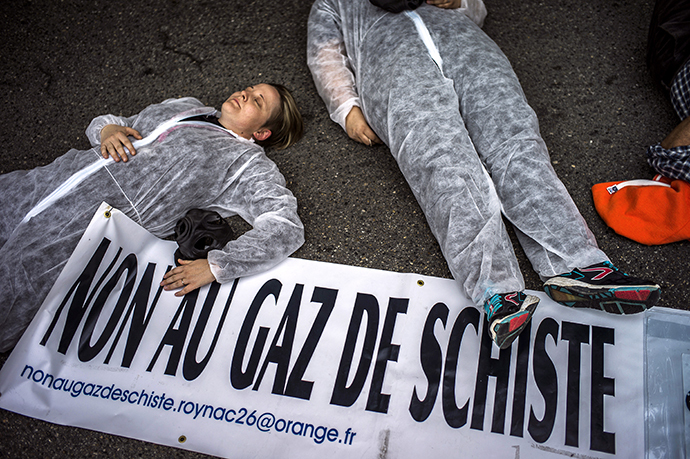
219 83 280 140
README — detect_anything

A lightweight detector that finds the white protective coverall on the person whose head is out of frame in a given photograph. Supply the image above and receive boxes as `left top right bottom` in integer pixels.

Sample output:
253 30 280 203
307 0 608 310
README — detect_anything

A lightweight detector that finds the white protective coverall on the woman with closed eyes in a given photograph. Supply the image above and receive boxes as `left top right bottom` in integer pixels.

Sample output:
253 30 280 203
0 98 304 352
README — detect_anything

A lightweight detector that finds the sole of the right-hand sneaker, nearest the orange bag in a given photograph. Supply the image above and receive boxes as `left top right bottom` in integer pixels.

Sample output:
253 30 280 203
544 277 661 315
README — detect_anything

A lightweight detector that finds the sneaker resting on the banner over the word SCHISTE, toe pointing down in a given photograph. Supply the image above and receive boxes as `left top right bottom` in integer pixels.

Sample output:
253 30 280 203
484 292 539 349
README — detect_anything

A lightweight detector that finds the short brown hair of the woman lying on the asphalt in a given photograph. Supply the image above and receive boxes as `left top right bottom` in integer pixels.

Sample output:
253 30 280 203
256 83 304 150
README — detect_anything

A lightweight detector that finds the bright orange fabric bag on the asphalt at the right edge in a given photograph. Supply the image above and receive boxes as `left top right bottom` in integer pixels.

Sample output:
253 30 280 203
592 175 690 245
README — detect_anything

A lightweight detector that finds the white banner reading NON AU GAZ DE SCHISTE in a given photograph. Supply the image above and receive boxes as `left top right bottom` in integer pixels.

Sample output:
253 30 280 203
0 204 645 459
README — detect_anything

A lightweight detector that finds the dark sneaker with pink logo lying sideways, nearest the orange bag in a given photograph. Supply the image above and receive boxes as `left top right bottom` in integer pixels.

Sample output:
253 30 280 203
544 261 661 314
